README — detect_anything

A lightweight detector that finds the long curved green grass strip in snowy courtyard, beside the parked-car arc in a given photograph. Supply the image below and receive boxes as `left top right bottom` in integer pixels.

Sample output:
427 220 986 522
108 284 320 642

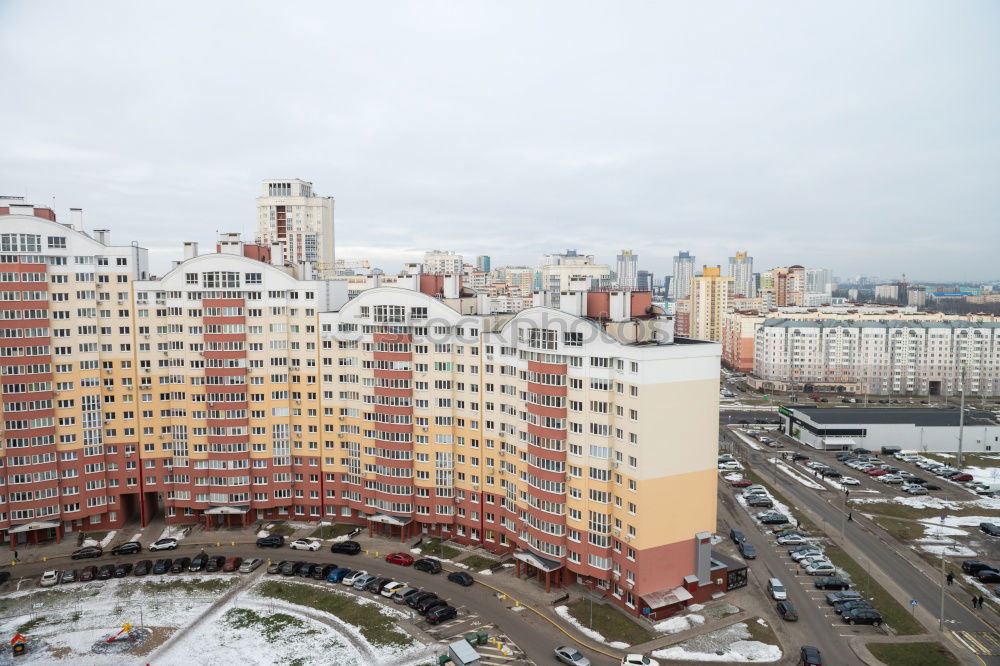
257 581 413 646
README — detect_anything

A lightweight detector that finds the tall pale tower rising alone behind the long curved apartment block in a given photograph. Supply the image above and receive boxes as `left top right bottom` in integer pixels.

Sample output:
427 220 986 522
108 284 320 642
257 179 336 279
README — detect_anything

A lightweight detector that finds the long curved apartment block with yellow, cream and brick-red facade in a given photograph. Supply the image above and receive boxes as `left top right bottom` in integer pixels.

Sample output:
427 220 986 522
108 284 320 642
0 206 726 619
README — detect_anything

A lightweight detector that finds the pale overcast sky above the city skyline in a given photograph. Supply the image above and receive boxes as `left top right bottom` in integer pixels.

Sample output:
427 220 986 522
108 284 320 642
0 0 1000 280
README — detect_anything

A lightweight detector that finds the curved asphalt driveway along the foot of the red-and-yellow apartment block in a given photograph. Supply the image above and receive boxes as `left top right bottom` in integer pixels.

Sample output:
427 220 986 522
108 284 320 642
5 532 619 666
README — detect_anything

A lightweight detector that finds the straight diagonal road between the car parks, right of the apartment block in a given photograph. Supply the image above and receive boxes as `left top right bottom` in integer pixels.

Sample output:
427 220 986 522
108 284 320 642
722 428 1000 666
